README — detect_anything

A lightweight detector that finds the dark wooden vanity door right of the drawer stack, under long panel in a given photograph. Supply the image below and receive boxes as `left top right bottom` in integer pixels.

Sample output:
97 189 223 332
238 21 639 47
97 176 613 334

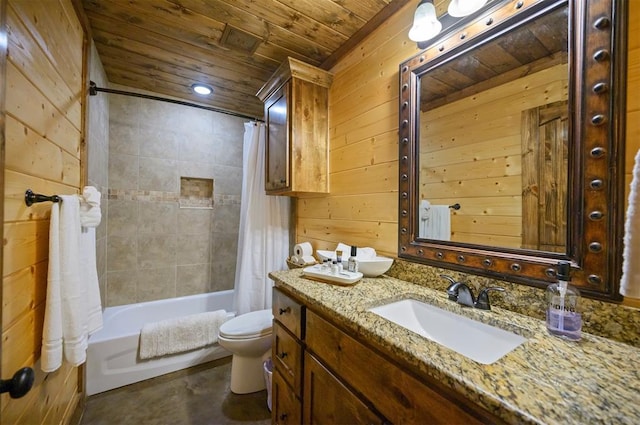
303 353 385 425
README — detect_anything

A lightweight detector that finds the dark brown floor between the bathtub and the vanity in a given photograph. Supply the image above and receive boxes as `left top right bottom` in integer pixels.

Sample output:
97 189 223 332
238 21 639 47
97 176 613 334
80 357 271 425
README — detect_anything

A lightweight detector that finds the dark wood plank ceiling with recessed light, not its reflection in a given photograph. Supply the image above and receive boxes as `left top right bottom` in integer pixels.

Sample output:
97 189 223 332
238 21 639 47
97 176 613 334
82 0 410 118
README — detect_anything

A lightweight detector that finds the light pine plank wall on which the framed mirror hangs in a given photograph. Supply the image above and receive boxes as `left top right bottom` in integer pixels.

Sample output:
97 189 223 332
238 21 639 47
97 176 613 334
295 1 640 276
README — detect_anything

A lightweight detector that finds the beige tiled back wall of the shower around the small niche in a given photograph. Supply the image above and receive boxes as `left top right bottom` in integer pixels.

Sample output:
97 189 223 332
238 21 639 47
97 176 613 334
103 86 246 306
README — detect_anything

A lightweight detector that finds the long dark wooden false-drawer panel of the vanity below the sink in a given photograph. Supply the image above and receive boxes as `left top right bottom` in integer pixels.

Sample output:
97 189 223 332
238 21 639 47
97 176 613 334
303 310 502 425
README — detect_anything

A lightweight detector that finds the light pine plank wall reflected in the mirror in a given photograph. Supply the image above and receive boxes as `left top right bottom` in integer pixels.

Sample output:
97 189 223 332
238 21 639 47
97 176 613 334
420 64 569 248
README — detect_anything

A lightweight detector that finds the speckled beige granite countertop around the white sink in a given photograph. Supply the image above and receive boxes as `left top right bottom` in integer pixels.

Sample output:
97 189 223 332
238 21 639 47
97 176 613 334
269 269 640 425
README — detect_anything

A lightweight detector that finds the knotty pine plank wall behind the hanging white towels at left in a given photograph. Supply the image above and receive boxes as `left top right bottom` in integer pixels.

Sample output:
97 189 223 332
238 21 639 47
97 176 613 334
1 0 84 425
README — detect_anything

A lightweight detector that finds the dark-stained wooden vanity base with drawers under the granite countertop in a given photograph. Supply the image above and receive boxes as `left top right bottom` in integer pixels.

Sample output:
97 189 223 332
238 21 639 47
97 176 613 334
272 287 503 424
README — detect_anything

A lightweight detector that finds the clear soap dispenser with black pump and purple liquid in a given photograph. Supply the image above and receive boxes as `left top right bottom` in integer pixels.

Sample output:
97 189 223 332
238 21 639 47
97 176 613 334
546 261 582 341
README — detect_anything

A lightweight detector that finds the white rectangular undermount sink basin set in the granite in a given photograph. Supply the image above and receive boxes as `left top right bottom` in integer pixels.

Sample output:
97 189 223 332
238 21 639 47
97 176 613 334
368 299 526 364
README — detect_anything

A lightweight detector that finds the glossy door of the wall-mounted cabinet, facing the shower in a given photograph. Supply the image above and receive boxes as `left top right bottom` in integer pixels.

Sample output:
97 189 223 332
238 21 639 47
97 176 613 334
264 83 291 192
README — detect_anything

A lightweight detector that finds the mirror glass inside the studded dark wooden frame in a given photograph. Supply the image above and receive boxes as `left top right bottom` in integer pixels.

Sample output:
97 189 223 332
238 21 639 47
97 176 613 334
418 5 569 252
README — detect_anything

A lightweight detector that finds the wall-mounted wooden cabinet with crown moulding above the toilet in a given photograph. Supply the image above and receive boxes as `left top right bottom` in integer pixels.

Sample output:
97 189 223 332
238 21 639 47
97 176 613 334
257 58 333 196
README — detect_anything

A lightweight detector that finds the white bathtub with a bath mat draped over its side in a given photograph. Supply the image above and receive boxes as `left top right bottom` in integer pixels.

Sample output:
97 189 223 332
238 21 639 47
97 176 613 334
86 290 234 395
